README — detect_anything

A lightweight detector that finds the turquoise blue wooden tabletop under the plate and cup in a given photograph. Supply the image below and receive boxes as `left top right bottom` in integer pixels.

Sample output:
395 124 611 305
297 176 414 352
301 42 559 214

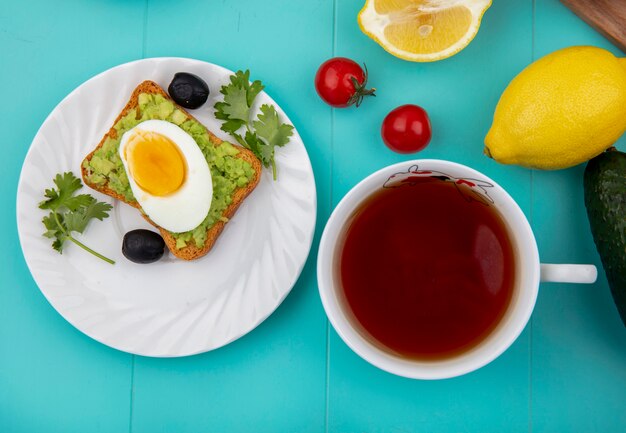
0 0 626 433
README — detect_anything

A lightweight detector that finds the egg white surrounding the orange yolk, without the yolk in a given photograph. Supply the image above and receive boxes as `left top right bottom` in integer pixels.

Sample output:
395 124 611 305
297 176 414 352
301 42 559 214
119 120 213 233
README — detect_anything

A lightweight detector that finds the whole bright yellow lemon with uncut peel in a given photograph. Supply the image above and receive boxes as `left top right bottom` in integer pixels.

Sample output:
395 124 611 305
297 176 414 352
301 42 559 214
485 46 626 170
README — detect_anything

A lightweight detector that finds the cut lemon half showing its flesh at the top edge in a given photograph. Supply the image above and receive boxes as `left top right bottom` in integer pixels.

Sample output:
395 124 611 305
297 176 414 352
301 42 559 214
358 0 491 62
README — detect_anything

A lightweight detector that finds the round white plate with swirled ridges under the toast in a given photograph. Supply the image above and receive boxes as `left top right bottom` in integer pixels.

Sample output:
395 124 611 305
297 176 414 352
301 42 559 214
17 58 316 357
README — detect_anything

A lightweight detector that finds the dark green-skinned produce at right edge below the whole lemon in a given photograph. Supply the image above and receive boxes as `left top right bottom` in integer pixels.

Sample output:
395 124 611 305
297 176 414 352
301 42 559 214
584 148 626 326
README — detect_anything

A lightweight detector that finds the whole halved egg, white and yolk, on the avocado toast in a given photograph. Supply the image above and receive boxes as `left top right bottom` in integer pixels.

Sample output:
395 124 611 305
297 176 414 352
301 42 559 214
119 120 213 233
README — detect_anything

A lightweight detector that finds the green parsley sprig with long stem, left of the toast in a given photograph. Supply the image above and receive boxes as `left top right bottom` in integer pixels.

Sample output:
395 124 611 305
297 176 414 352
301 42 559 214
39 172 115 265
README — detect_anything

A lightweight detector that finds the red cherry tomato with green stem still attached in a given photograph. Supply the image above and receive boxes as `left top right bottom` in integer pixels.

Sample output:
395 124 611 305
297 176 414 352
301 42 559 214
315 57 376 108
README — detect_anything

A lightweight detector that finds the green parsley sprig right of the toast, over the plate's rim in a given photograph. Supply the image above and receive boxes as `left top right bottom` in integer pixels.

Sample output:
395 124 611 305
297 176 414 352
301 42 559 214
215 71 293 180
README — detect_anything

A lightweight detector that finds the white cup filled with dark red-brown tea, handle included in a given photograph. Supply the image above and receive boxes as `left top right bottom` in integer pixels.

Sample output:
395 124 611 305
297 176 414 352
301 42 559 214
317 160 597 379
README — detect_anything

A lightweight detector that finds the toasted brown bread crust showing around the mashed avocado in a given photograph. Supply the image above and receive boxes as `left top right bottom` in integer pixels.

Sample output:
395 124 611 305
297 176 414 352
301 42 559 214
81 81 262 260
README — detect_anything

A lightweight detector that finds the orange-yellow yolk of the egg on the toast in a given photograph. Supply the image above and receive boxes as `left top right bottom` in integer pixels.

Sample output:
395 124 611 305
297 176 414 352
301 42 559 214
124 131 185 197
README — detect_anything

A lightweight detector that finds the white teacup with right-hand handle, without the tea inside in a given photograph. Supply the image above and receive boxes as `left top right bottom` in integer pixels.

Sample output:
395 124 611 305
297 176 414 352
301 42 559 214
317 159 597 379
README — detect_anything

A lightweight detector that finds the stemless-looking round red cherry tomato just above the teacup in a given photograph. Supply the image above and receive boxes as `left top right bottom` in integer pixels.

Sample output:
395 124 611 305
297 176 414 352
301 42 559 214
380 104 432 153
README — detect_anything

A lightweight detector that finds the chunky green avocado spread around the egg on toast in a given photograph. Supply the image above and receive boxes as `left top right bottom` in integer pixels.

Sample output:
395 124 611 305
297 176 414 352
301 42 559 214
83 93 254 249
